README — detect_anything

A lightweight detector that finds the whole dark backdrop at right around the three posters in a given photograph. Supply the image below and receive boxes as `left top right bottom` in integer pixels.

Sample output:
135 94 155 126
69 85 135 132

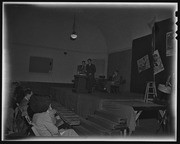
130 19 174 93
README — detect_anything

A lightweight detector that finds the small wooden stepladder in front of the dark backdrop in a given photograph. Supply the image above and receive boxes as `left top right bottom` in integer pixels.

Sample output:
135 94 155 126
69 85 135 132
144 81 157 102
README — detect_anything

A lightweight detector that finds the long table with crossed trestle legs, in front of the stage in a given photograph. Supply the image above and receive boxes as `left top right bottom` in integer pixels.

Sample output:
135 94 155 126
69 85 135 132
100 99 167 133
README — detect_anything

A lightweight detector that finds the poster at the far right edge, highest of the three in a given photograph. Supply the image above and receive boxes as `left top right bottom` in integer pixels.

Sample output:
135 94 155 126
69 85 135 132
166 31 175 56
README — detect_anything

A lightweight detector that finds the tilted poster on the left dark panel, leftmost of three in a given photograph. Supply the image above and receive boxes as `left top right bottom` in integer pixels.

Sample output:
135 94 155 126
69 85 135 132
137 55 150 73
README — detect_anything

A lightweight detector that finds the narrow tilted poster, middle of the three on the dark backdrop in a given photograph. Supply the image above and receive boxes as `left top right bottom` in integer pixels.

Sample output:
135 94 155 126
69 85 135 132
153 50 164 75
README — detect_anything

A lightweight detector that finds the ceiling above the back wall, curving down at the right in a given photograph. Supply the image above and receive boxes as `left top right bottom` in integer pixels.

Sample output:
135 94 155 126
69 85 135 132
6 3 176 52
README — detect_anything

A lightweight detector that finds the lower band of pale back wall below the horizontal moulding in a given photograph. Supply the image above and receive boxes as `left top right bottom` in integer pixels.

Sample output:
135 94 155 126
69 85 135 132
8 40 107 83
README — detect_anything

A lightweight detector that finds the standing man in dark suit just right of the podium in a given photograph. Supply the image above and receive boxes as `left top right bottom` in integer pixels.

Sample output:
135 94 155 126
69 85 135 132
86 59 96 93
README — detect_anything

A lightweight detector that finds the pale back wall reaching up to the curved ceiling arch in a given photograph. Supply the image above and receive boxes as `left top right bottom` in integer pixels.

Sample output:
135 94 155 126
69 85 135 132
5 5 107 83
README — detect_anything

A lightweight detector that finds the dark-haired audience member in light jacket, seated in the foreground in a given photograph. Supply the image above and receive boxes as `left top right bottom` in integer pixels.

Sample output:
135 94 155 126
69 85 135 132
32 99 78 136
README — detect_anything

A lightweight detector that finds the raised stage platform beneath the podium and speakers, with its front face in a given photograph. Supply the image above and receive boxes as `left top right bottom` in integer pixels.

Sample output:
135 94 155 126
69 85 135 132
51 87 144 118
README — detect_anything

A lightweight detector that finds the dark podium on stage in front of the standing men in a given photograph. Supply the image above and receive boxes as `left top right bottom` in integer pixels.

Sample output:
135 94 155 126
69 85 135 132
74 74 87 92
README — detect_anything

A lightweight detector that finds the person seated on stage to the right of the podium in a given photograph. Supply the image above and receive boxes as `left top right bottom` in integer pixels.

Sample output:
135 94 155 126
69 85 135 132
104 70 122 93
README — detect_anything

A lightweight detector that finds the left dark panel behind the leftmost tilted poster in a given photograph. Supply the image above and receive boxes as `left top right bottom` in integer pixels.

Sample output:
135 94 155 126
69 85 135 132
130 35 153 93
